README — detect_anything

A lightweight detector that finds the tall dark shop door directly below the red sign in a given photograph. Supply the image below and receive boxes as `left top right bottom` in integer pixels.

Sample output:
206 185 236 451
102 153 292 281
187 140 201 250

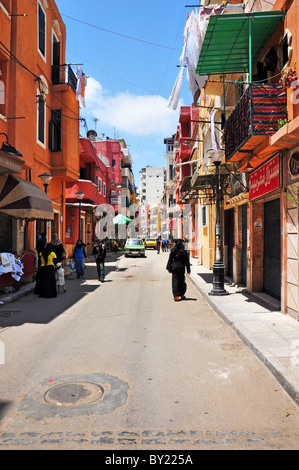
263 199 281 300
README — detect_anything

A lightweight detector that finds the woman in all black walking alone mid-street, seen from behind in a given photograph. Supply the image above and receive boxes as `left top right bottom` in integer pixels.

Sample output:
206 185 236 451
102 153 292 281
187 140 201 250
166 239 191 302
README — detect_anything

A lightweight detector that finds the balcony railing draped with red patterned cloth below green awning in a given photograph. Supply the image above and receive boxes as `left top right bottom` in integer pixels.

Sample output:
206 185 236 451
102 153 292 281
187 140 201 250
224 84 287 161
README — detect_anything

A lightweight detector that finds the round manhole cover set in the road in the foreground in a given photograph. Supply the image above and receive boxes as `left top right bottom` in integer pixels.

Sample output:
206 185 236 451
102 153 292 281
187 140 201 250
44 382 104 406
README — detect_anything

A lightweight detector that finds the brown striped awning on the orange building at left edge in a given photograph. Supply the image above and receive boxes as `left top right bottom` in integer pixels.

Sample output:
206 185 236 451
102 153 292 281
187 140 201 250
0 175 54 220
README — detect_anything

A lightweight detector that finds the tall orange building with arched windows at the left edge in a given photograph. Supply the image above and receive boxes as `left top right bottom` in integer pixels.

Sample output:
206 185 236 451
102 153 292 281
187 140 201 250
0 0 79 260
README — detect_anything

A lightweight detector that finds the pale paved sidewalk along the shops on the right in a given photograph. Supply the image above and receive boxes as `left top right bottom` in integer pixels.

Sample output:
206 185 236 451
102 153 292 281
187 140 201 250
188 258 299 405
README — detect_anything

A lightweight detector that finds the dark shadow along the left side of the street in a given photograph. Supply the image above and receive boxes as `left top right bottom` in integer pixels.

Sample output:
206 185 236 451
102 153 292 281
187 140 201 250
0 253 122 328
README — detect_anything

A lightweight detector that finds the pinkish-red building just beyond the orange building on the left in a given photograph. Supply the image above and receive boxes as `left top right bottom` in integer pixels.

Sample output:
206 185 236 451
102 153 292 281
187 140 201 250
65 131 124 256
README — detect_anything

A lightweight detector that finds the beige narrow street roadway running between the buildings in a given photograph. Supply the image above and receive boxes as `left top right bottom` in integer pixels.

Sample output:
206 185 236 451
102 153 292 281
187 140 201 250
0 250 299 450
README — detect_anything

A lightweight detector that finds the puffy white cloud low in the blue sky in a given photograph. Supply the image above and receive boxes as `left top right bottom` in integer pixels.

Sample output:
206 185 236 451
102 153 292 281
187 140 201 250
85 77 179 137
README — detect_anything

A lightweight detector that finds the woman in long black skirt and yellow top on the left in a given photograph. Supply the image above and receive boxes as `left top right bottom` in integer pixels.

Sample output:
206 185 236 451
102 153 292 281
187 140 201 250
34 243 57 299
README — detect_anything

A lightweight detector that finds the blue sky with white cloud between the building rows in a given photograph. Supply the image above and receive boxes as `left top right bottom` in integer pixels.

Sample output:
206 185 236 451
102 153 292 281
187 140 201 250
56 0 196 185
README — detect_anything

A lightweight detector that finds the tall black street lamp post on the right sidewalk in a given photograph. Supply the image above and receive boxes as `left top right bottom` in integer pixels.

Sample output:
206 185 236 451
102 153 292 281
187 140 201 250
208 150 229 295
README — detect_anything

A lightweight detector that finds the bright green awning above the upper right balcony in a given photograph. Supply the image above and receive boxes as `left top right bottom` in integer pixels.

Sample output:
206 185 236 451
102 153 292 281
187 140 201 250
196 11 284 81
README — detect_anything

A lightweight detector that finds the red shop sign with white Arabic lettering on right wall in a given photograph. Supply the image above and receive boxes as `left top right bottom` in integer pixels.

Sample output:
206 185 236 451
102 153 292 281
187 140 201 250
249 155 280 201
